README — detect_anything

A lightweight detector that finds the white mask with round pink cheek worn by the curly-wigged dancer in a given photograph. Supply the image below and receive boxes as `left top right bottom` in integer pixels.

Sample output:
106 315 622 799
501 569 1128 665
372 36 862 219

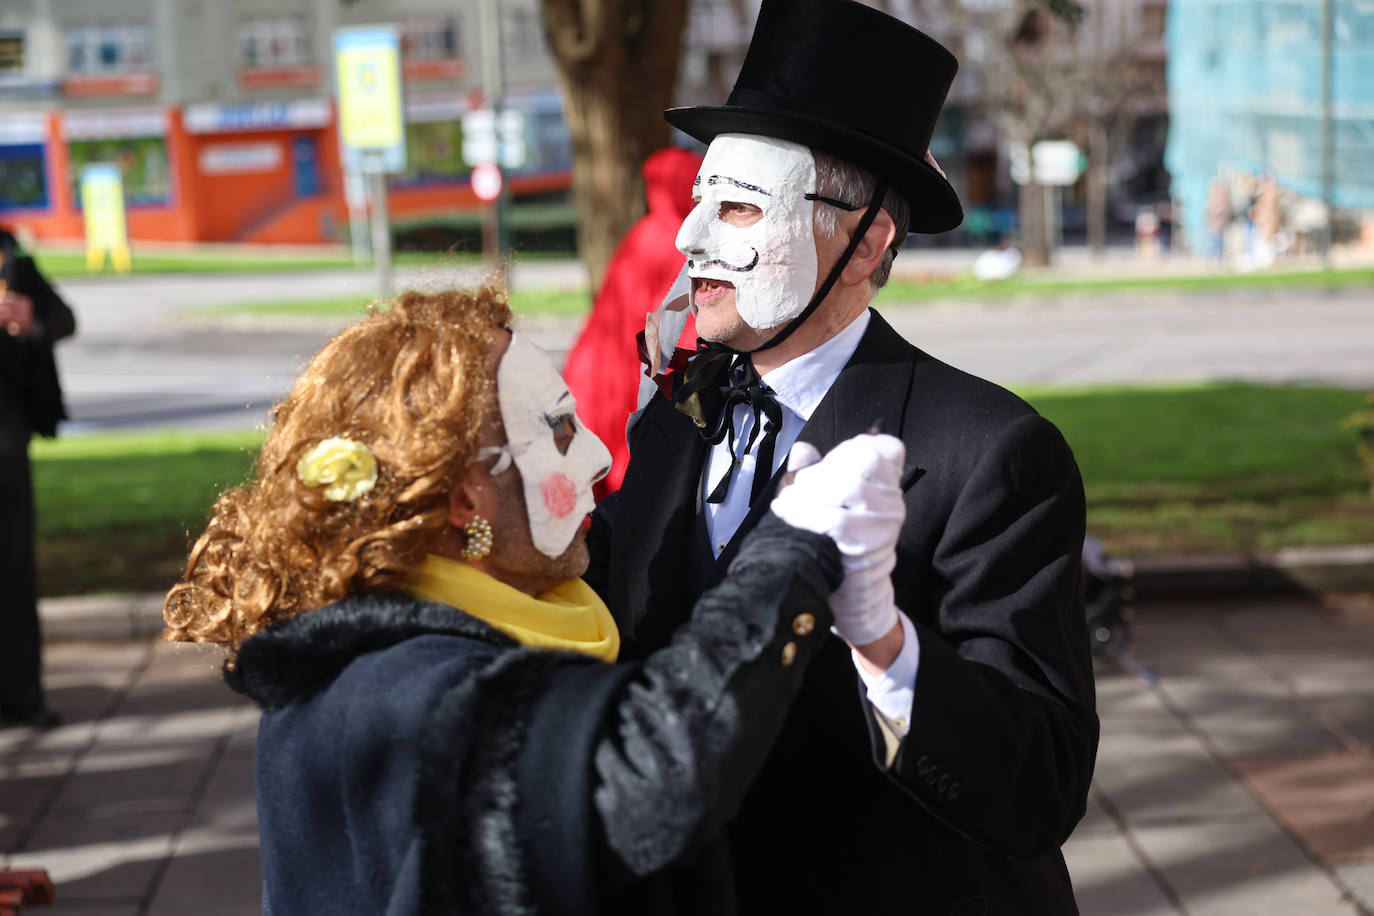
492 332 610 558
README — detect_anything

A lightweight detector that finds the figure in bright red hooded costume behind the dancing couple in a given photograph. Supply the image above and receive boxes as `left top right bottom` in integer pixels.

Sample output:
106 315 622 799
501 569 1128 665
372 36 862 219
563 147 701 500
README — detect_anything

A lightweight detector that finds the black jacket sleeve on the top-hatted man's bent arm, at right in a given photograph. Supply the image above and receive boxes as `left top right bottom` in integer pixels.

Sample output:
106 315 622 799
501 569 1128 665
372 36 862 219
874 415 1098 858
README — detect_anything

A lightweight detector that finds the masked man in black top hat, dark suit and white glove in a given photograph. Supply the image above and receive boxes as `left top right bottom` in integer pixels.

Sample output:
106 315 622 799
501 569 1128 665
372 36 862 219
589 0 1098 916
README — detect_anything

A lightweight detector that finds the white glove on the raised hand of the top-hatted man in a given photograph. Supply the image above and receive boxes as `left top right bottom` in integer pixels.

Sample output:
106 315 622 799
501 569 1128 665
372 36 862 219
772 435 907 645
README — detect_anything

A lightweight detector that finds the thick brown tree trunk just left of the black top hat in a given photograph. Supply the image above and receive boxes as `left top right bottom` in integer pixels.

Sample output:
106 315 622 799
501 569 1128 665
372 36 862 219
543 0 688 290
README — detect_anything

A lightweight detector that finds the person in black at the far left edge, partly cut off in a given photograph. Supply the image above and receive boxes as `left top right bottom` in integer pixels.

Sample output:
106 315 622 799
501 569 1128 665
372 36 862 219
0 228 76 728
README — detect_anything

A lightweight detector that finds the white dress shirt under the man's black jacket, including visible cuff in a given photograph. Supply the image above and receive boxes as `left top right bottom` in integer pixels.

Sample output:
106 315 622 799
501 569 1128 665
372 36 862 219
701 309 921 737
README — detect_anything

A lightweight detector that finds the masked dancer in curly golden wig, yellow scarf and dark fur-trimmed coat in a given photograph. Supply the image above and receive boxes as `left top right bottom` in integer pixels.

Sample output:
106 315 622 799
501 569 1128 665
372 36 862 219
165 287 900 915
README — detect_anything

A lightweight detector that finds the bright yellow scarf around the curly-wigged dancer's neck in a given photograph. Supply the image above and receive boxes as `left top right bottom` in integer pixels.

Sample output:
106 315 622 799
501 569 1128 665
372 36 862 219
401 553 620 662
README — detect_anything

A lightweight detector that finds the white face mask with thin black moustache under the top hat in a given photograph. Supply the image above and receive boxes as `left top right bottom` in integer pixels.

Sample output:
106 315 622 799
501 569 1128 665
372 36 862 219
677 133 816 331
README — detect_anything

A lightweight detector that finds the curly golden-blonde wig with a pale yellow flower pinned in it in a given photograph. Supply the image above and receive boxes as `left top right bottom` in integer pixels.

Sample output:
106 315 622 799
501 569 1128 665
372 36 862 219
162 286 511 655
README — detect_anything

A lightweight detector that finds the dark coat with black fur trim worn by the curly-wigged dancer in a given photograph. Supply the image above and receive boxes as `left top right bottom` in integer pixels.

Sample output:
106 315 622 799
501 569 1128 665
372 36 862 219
225 518 841 916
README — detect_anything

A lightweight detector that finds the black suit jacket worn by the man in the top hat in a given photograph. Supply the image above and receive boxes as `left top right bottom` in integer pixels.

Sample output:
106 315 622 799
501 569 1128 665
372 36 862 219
588 313 1098 916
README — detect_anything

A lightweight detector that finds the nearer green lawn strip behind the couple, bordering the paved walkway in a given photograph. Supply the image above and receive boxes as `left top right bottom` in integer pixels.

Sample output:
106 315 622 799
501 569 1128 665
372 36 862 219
33 385 1374 595
